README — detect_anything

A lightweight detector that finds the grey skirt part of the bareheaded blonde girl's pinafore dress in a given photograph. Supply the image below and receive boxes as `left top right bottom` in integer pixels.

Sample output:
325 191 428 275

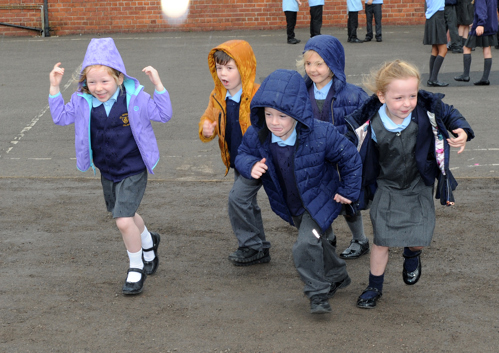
370 176 435 247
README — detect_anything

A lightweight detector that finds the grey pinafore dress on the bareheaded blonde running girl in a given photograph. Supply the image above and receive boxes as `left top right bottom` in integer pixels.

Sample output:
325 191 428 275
370 114 435 247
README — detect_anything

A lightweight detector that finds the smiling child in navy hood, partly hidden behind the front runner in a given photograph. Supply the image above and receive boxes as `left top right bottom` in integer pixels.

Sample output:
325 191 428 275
296 35 369 259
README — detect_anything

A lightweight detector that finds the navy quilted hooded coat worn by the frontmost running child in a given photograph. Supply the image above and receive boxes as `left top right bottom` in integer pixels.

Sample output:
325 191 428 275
236 70 362 232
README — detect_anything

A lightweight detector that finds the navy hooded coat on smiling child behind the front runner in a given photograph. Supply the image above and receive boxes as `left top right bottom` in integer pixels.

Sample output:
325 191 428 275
304 35 369 135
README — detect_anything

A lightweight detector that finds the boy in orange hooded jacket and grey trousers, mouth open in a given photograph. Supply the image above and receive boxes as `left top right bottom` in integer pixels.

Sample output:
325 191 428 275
199 40 270 266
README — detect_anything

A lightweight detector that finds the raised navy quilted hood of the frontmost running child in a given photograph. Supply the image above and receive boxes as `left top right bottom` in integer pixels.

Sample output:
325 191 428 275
251 69 314 137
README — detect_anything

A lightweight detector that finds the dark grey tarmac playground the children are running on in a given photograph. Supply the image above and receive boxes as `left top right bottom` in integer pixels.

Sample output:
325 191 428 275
0 26 499 353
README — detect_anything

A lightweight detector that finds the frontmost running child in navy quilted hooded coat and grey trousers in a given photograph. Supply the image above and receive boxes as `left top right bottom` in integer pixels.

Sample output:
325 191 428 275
235 70 362 314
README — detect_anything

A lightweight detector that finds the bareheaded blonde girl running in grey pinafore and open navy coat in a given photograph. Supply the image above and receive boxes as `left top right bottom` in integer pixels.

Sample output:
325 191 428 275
347 60 474 309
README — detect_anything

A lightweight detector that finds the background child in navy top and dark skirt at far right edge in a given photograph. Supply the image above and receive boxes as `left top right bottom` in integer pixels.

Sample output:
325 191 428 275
454 0 498 86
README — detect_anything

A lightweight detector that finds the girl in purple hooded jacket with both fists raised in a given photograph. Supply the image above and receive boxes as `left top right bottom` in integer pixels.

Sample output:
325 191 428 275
49 38 172 294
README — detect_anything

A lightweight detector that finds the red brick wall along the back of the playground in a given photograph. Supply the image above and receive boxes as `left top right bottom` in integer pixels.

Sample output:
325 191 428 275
0 0 424 36
